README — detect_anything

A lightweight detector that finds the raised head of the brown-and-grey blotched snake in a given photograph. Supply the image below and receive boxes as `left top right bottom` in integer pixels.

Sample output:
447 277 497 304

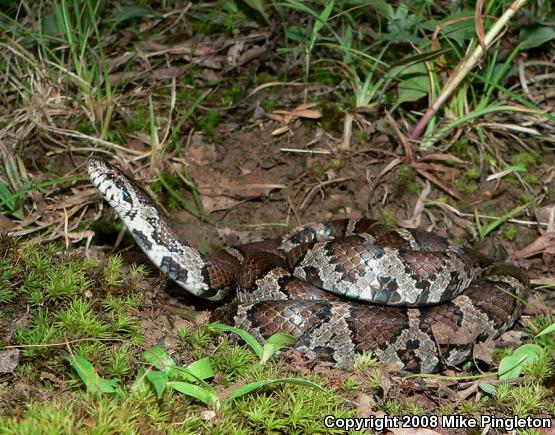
87 159 141 220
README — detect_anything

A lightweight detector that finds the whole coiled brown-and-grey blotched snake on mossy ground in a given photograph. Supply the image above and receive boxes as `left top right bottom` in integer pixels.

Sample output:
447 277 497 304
87 159 530 373
